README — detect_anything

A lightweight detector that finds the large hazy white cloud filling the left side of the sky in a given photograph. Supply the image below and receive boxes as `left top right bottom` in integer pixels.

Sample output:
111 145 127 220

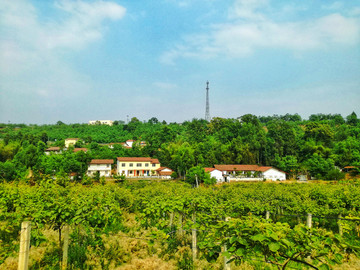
0 0 126 121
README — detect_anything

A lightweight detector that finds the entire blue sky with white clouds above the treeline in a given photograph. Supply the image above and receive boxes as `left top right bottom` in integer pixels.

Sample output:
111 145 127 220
0 0 360 124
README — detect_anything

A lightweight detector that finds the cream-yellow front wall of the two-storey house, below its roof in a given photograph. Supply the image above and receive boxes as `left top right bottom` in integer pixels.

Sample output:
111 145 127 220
117 160 160 177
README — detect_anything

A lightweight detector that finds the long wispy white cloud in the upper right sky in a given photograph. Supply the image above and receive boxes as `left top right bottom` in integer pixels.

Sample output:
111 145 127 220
160 0 360 64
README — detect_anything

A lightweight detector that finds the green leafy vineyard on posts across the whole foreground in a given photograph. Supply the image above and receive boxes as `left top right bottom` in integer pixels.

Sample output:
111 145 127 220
0 180 360 269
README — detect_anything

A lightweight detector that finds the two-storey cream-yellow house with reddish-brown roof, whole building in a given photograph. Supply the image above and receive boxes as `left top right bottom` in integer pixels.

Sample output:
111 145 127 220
117 157 161 177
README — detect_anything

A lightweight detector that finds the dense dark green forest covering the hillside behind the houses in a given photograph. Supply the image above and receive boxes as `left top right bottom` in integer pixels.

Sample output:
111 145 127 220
0 112 360 181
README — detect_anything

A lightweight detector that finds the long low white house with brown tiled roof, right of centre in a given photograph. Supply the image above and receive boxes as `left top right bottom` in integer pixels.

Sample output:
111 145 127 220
214 164 286 181
